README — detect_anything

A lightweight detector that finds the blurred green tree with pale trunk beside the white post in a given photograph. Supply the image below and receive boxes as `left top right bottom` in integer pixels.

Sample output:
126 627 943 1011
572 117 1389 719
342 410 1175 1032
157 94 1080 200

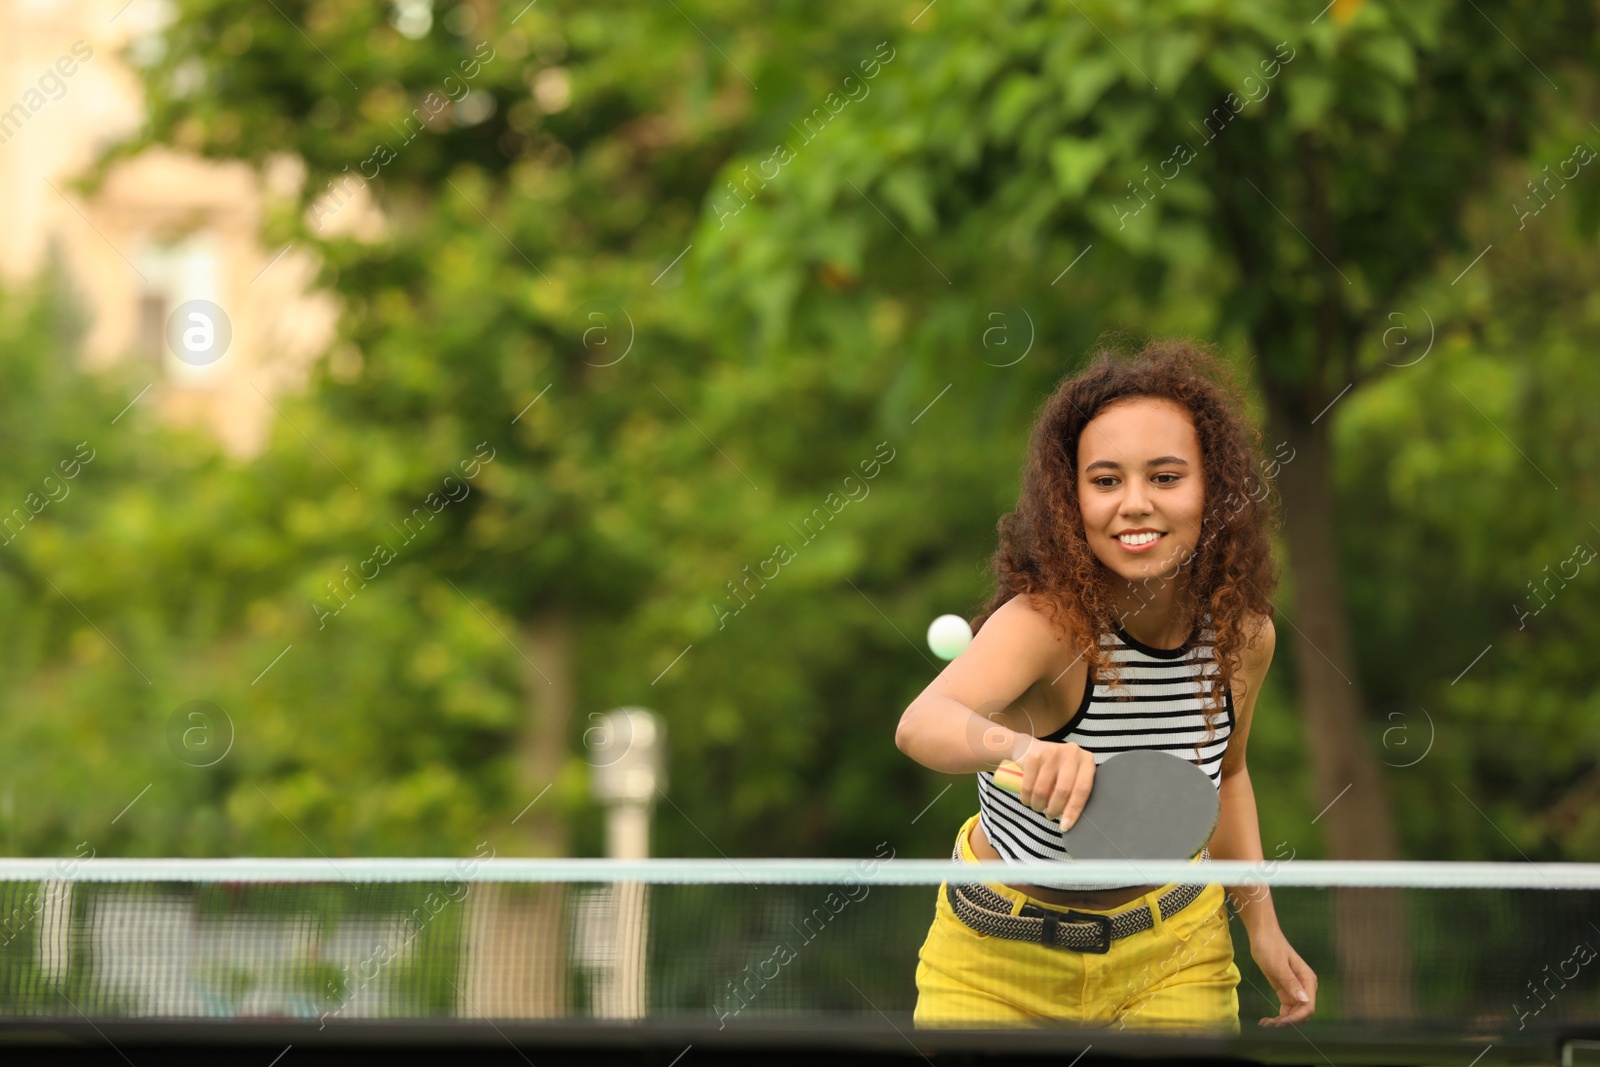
90 0 934 851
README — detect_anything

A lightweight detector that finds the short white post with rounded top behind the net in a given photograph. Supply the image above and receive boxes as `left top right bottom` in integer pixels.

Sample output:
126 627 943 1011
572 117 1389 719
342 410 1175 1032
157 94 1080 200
584 707 667 1019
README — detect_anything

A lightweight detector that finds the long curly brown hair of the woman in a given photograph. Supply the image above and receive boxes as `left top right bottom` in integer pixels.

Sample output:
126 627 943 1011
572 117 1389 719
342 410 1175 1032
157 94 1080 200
973 339 1282 734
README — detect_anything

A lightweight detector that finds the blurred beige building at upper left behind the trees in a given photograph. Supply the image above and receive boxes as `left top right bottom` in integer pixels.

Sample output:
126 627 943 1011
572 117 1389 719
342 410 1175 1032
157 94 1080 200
0 0 336 454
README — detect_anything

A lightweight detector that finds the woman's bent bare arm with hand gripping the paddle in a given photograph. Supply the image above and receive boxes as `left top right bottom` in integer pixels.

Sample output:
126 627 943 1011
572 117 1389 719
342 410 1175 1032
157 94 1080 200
894 598 1094 825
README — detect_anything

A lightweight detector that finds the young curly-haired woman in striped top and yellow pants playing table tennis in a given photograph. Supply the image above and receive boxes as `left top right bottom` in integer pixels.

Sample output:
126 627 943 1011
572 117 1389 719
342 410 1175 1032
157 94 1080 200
894 341 1317 1033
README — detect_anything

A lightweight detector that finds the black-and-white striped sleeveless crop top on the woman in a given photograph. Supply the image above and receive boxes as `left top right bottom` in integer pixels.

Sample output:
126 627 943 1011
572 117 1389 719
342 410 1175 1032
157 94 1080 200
978 616 1234 889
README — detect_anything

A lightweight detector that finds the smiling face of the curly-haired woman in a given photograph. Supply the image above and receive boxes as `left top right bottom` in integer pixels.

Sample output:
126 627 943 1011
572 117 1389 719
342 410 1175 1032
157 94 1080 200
1078 397 1205 605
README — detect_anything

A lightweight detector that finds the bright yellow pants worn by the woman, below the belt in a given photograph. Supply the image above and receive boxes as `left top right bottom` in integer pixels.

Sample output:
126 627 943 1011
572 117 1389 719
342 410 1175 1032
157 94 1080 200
914 816 1238 1035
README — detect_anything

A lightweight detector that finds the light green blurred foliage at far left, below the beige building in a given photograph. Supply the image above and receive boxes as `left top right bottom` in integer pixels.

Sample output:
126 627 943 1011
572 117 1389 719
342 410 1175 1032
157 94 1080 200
0 271 520 854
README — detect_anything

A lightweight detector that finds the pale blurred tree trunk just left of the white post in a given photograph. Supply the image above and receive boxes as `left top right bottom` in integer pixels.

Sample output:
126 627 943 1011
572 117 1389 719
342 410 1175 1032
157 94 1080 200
458 613 576 1019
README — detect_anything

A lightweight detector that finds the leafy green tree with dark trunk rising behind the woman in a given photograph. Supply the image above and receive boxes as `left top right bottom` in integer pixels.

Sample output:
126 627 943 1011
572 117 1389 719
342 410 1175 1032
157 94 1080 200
688 0 1597 1017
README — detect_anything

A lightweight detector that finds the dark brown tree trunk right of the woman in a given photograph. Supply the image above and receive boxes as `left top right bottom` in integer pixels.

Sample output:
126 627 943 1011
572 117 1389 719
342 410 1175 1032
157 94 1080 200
1267 389 1413 1021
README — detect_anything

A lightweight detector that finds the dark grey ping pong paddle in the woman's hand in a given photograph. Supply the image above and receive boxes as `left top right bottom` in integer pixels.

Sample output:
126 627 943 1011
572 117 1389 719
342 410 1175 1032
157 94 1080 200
995 749 1222 859
